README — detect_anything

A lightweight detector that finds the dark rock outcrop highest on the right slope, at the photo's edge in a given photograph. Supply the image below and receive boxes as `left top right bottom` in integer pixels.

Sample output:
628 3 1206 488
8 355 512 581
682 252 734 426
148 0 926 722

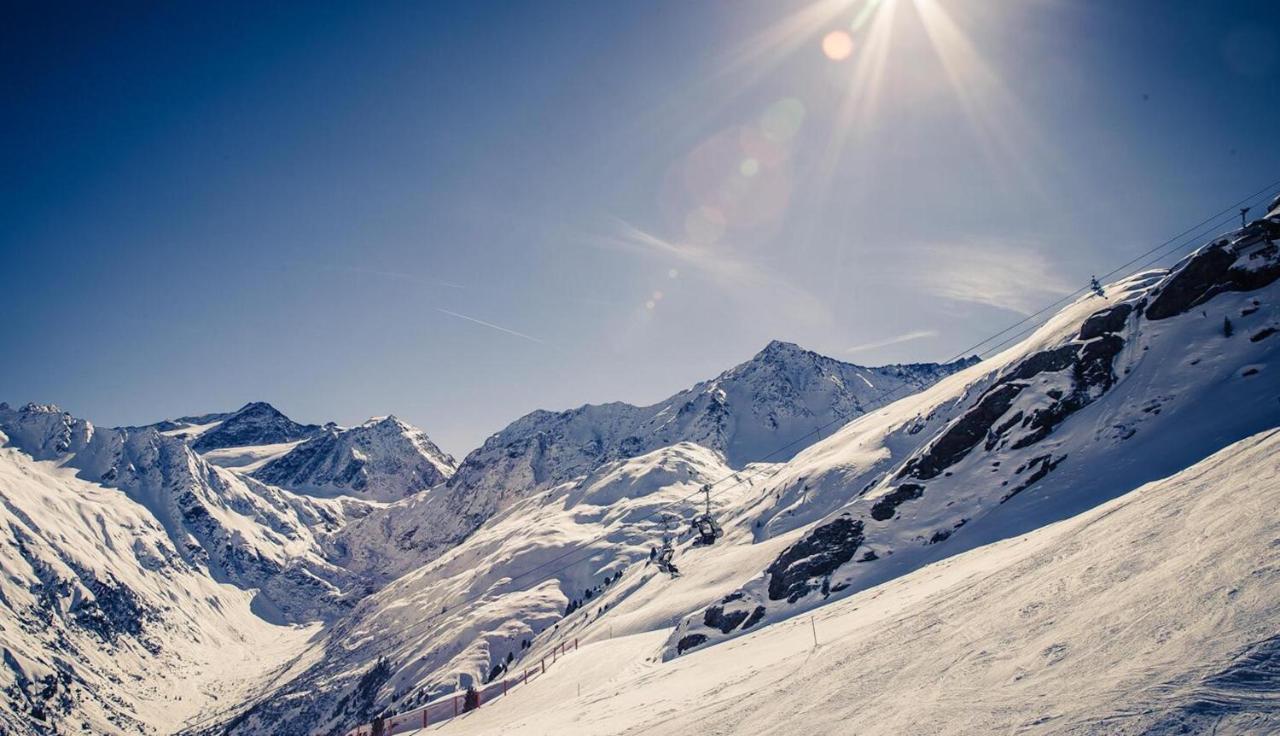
1147 241 1280 320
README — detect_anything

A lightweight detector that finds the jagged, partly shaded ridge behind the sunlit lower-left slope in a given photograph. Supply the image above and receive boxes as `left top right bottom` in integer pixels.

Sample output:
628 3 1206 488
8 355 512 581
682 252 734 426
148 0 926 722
0 404 366 621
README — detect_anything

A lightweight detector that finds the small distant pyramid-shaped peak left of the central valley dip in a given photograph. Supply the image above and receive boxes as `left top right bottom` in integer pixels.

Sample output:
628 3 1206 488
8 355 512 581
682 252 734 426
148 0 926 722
252 416 457 500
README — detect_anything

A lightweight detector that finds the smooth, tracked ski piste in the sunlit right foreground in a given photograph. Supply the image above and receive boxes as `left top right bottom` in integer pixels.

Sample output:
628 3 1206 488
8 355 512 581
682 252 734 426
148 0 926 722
420 430 1280 735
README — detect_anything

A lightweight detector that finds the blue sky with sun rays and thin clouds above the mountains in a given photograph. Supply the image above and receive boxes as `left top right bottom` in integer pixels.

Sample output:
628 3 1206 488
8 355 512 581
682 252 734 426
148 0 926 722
0 0 1280 456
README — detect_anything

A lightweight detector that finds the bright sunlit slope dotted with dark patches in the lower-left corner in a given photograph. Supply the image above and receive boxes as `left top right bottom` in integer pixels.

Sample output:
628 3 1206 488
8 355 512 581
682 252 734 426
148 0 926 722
0 430 314 735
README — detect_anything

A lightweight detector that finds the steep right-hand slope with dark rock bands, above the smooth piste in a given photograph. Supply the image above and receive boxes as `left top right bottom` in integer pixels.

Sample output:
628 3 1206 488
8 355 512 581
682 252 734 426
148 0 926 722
666 223 1280 657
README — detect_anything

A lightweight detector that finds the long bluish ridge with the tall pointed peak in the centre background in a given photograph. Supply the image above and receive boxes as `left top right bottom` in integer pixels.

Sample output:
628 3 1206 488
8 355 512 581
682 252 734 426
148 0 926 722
335 342 977 577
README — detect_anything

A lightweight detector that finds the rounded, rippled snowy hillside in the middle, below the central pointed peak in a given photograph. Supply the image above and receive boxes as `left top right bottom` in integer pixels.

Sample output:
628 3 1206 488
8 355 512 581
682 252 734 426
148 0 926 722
200 443 786 735
